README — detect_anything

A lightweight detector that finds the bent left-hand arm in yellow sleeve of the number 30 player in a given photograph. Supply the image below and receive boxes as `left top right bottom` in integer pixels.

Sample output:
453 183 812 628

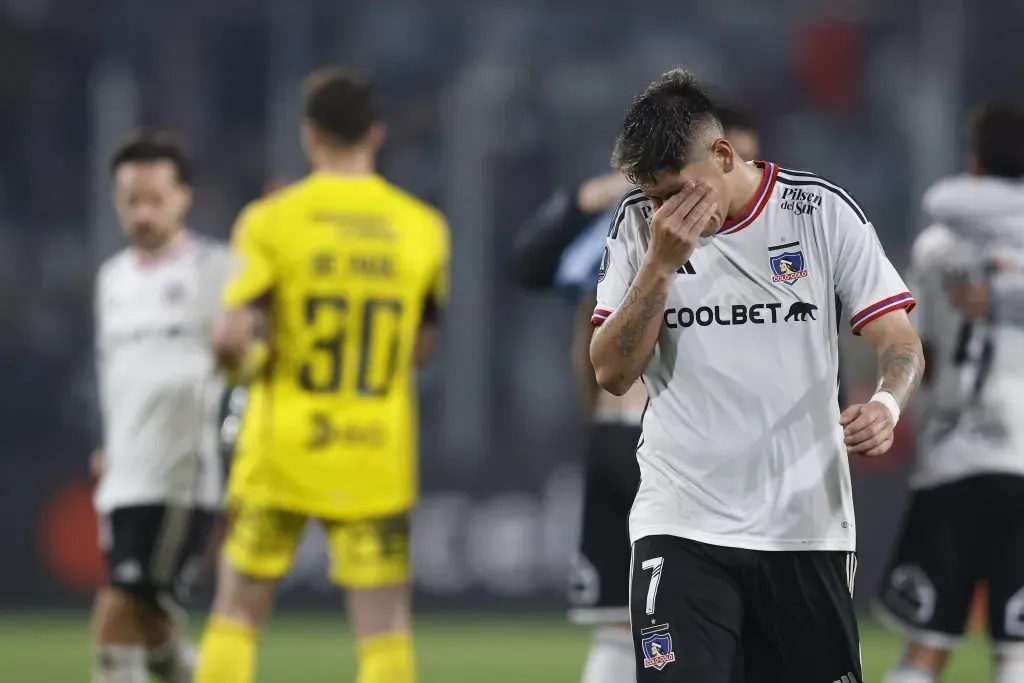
213 204 276 381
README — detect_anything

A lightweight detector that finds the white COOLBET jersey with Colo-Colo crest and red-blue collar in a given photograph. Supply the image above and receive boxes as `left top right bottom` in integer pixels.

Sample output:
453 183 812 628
594 163 913 551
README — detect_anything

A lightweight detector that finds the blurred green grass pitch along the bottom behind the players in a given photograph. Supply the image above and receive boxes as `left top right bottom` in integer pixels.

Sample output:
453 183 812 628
0 614 989 683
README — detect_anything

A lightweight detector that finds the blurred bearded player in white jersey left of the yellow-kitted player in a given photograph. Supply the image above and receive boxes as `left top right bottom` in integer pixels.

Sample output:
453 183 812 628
92 135 226 683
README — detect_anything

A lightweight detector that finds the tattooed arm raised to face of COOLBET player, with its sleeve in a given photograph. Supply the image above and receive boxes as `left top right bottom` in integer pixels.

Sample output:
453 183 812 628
590 183 716 396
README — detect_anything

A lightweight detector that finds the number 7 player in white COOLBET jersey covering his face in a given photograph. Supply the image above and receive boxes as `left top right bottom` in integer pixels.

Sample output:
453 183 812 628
591 71 924 683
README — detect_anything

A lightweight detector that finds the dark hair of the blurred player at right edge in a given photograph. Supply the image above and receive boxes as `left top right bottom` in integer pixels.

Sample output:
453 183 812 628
968 101 1024 178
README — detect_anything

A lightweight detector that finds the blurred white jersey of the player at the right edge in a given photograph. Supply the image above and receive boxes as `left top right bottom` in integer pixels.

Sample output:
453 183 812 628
910 176 1024 488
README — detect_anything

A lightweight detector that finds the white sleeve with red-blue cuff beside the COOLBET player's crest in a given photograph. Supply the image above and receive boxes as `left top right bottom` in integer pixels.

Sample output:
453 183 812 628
831 191 914 335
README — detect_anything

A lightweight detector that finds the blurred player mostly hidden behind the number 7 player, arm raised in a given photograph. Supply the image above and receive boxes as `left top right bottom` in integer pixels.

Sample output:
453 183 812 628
513 105 759 683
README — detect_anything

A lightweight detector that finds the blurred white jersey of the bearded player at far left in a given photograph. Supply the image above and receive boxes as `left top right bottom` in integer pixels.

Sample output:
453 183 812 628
95 236 227 513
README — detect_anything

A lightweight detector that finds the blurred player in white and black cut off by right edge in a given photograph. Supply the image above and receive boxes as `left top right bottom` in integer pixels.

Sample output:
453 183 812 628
879 103 1024 683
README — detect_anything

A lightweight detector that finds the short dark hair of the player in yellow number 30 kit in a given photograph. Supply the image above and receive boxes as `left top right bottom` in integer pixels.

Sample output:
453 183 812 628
303 67 380 146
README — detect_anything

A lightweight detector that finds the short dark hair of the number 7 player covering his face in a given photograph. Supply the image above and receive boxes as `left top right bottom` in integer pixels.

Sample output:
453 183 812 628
611 69 723 184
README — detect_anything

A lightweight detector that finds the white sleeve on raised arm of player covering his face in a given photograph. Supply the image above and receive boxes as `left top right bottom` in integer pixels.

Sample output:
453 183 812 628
591 188 647 327
